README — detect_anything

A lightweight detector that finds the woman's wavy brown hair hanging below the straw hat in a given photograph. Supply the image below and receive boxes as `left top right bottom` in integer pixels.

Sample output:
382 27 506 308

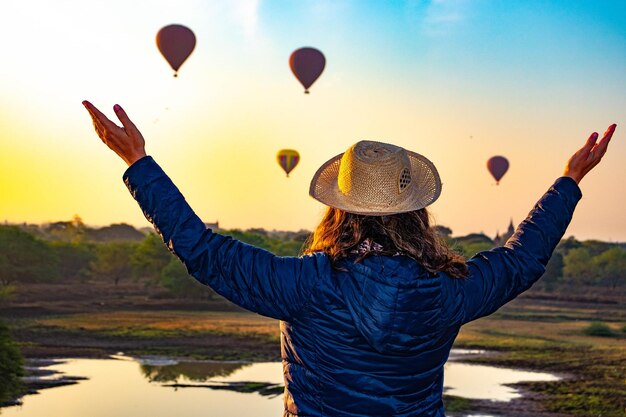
303 207 468 278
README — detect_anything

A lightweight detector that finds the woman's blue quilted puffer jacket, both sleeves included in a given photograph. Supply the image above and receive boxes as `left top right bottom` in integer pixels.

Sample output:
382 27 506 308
124 157 581 417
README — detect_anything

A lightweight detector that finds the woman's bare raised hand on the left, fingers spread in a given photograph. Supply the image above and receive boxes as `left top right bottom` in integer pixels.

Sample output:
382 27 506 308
83 100 146 166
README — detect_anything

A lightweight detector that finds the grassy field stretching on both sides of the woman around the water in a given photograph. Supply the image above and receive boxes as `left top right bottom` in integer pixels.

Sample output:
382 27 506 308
2 290 626 417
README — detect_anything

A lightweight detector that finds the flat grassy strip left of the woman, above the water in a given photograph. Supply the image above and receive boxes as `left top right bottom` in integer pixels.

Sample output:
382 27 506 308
9 311 280 361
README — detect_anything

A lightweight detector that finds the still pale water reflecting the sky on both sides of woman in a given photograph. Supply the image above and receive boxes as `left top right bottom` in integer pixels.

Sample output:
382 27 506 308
0 352 557 417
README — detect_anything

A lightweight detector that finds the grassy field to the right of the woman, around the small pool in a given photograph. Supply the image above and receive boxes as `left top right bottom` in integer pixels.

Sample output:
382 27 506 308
456 298 626 417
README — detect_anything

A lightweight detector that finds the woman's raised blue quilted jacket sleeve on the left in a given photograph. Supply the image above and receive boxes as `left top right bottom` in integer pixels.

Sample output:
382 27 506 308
124 156 326 320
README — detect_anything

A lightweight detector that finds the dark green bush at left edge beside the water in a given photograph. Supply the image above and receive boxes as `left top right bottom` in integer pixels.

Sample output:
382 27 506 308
0 322 24 404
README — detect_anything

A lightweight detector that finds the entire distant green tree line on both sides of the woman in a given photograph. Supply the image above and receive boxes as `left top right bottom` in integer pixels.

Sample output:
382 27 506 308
0 221 626 297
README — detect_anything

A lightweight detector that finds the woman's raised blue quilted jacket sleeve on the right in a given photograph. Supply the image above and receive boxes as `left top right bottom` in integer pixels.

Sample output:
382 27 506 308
447 177 582 324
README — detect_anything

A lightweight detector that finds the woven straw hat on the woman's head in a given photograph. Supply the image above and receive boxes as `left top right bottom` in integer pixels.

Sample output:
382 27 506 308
309 140 441 216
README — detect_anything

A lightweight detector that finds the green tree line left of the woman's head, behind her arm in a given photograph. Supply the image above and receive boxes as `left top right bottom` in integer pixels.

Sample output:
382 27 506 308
0 218 308 298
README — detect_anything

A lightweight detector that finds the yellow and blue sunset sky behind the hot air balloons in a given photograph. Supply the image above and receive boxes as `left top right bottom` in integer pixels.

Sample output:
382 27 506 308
0 0 626 241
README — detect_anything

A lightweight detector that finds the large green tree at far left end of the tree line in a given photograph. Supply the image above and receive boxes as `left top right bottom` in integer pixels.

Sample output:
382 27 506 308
0 226 59 286
